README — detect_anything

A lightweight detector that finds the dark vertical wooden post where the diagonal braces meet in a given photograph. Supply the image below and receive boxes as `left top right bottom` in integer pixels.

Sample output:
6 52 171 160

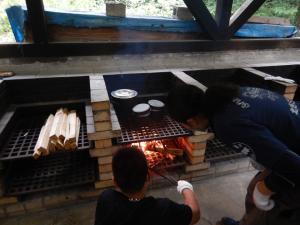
215 0 233 36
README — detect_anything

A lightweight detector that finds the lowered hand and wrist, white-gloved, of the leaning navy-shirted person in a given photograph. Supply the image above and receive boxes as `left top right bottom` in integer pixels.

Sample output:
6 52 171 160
253 181 275 211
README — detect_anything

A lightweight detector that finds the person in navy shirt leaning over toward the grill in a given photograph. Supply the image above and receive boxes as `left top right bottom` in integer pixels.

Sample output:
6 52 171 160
167 84 300 225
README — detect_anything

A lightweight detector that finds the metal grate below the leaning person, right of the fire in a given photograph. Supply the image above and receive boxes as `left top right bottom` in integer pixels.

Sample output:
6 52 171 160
205 138 245 161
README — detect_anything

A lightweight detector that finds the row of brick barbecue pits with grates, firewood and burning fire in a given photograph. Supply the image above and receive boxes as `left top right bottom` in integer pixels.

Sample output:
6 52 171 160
0 66 297 218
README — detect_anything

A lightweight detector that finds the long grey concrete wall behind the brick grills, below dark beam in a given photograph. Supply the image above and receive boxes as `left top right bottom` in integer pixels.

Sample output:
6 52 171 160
0 46 300 75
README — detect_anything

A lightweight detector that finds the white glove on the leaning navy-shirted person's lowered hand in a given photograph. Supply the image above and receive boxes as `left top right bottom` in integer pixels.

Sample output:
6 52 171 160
253 181 275 211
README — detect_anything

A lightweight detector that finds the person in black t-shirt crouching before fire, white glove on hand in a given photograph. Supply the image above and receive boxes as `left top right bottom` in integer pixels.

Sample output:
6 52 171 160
95 147 200 225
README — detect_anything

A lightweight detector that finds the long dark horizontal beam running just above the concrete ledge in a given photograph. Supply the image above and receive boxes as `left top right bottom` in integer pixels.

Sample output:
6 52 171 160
0 38 300 58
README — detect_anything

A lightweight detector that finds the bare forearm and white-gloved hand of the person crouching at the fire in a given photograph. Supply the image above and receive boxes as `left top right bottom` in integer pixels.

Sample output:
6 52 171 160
177 180 200 225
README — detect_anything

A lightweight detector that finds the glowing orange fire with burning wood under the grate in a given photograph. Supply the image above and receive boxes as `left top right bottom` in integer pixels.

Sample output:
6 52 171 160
131 140 183 168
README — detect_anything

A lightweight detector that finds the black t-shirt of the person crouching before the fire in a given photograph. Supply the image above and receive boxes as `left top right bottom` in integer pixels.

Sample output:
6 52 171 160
95 190 192 225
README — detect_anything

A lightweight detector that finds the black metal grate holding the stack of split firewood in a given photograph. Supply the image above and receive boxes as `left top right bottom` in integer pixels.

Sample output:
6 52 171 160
0 103 91 161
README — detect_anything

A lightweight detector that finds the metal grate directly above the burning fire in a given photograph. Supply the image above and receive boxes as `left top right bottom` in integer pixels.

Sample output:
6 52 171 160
117 116 192 144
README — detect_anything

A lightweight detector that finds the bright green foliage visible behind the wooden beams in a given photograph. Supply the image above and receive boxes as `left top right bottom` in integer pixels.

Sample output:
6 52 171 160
0 0 300 43
